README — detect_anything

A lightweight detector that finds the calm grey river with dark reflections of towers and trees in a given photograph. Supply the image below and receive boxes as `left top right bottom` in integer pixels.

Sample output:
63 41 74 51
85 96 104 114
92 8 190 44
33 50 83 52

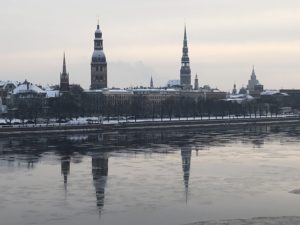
0 126 300 225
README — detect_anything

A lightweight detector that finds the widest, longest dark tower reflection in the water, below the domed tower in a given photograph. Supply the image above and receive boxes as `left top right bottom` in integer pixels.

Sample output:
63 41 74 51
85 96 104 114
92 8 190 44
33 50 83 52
92 153 108 215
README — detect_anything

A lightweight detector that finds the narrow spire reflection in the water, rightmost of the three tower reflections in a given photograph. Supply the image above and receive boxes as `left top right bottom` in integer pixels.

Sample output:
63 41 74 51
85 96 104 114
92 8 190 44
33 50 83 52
181 146 192 203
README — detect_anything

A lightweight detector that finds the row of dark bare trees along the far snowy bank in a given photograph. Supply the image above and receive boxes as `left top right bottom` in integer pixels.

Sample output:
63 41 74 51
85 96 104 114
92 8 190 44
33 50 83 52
6 86 299 123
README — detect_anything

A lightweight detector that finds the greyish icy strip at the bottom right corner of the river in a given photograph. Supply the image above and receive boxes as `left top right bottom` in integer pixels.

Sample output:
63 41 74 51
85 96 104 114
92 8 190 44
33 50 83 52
184 217 300 225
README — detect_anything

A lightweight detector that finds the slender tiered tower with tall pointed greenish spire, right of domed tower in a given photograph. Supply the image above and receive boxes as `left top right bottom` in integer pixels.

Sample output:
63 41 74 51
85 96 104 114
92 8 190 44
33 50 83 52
180 26 192 89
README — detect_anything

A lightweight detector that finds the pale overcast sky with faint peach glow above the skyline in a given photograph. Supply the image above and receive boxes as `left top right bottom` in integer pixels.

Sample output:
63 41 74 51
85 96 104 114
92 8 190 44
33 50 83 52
0 0 300 91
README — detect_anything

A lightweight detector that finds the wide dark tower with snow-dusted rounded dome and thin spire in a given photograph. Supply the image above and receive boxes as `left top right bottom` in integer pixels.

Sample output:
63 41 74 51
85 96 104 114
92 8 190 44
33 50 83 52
90 22 107 90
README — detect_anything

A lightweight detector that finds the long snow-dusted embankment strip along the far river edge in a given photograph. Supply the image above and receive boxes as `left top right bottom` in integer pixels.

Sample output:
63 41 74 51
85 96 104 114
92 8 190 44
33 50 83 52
0 116 300 136
